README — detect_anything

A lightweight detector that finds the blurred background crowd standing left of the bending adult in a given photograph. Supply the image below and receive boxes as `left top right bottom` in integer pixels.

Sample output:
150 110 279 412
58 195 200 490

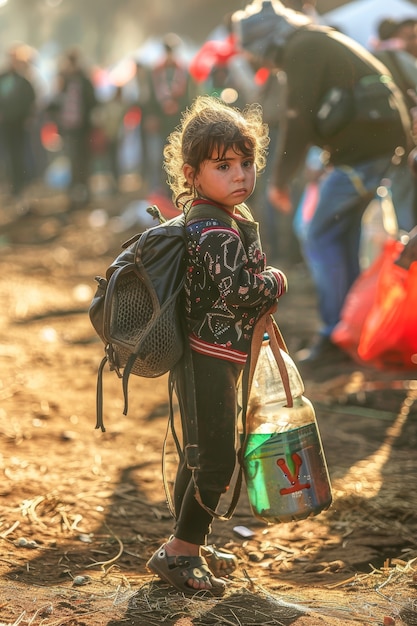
0 22 254 208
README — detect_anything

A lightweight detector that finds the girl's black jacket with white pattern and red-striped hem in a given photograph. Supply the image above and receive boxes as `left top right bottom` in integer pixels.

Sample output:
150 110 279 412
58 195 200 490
185 200 287 364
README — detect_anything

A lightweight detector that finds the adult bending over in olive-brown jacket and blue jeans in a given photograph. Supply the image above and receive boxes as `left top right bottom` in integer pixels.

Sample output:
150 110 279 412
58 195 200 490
233 0 413 364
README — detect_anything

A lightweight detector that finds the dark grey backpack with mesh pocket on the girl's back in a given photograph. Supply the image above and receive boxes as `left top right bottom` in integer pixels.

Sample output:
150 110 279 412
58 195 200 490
89 207 186 431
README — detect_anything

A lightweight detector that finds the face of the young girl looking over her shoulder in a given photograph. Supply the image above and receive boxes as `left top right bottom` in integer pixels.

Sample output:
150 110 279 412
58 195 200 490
184 148 256 211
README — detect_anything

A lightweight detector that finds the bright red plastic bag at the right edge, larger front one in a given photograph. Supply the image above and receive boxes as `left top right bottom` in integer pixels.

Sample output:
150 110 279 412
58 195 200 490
358 240 417 369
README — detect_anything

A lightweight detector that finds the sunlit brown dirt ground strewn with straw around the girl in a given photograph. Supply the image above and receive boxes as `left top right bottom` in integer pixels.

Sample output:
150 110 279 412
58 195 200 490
0 178 417 626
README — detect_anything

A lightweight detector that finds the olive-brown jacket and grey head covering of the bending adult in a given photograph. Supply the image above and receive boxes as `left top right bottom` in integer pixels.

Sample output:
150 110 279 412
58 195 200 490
235 2 412 187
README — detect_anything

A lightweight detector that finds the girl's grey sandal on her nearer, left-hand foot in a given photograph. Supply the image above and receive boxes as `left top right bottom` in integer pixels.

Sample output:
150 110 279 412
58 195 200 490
146 544 226 597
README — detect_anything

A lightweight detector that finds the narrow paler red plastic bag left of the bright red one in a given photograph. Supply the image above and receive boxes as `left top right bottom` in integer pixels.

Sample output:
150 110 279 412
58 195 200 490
331 239 404 361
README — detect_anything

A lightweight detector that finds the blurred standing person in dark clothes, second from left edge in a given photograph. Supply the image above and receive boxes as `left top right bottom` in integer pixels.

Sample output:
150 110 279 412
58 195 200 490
54 49 97 208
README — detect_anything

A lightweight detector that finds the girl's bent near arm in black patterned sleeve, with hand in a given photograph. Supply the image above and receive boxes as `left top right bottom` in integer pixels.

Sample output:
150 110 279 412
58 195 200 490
198 226 286 308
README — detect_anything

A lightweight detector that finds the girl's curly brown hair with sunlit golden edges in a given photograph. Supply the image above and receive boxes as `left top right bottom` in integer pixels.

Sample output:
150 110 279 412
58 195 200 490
164 96 269 208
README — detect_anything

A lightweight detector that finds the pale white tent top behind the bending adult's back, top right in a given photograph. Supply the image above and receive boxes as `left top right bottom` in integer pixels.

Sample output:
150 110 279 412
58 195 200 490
321 0 417 48
